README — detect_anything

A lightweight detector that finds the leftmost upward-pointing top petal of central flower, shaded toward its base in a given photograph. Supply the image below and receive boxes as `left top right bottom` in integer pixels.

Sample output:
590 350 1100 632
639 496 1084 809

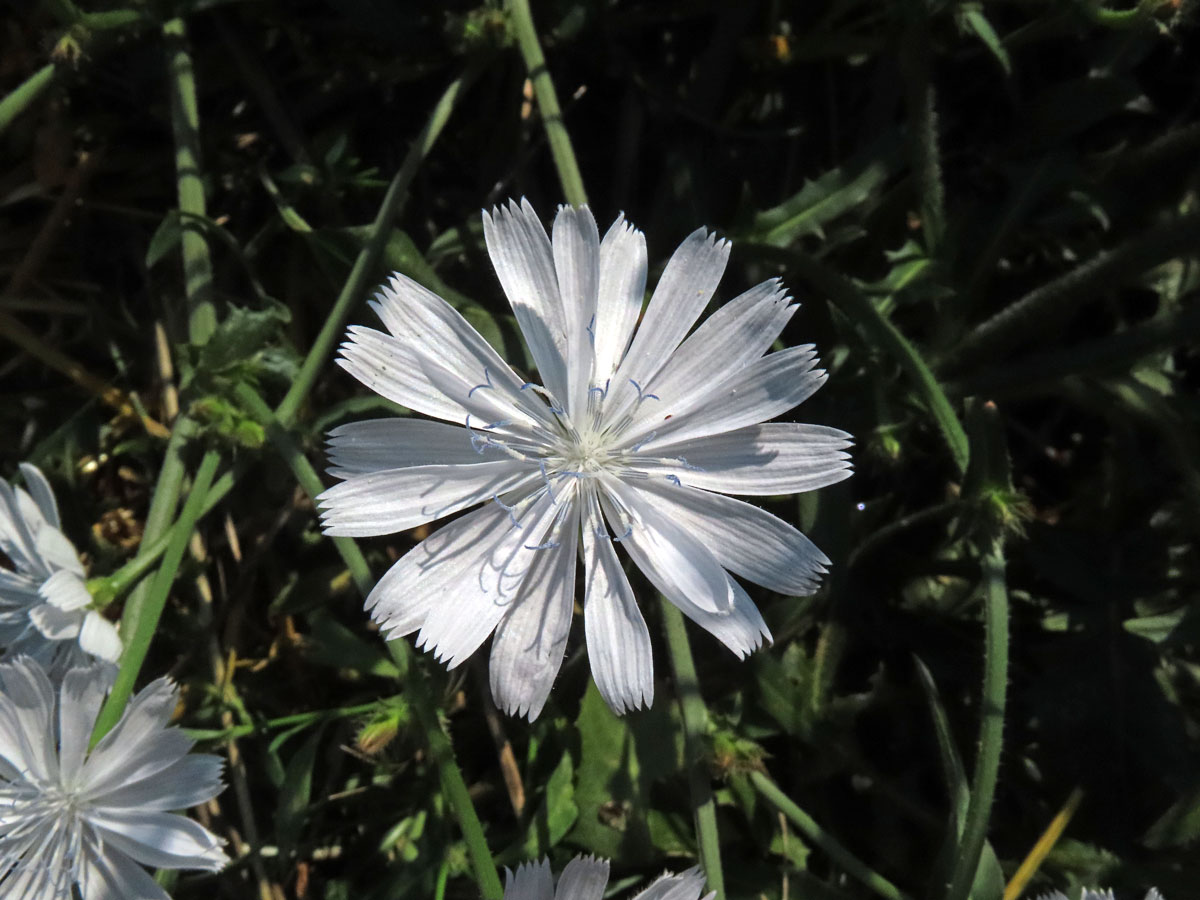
484 200 568 403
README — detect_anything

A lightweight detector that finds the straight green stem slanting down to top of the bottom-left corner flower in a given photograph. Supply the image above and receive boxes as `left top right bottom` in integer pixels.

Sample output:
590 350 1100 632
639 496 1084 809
91 450 221 746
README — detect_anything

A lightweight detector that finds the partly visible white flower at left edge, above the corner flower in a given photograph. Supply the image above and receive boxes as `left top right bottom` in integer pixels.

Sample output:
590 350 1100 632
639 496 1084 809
0 462 121 678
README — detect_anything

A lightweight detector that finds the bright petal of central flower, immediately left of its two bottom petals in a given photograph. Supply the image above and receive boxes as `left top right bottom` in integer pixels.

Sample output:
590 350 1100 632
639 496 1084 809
416 490 569 668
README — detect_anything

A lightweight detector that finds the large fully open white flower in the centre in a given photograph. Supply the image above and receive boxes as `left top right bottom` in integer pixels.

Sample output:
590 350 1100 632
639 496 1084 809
319 203 851 720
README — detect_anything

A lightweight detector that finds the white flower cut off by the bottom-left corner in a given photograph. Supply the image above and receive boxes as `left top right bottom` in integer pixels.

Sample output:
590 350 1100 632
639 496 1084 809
0 658 228 900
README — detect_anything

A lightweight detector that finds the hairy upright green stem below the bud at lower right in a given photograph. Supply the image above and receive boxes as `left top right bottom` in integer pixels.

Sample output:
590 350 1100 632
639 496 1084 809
946 538 1008 900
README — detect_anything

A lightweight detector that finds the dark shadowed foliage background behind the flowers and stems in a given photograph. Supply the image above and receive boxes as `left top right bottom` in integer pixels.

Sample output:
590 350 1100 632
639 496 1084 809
0 0 1200 900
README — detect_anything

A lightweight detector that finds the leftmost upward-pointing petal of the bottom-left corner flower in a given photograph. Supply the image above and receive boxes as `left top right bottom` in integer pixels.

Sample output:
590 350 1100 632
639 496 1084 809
0 658 59 781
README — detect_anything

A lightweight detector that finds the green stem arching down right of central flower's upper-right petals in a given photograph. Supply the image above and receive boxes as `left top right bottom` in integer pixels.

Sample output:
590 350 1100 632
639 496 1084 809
743 244 971 474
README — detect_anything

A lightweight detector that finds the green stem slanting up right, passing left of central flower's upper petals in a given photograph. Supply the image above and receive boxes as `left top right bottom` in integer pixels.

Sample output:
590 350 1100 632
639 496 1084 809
276 68 476 427
